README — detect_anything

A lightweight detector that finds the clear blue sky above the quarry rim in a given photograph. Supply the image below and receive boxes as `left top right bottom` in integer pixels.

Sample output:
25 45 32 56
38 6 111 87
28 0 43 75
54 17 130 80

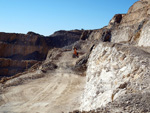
0 0 138 36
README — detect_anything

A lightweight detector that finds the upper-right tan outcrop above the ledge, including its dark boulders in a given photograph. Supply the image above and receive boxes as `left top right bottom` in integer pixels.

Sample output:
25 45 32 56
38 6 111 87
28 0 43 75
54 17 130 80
88 0 150 47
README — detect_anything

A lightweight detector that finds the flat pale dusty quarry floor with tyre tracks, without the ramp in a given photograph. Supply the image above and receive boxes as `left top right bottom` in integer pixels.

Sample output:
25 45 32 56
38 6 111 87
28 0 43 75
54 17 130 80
0 69 85 113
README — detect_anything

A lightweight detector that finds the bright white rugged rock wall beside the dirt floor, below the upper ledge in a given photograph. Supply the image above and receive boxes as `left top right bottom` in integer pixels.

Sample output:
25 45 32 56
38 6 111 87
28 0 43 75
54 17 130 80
81 43 150 112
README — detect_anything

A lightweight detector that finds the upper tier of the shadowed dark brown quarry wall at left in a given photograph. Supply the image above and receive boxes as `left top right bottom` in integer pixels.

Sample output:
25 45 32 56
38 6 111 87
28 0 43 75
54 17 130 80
0 32 49 60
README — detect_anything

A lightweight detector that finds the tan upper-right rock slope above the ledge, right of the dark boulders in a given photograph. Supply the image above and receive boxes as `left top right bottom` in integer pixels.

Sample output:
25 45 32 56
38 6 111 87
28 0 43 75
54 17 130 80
111 0 150 46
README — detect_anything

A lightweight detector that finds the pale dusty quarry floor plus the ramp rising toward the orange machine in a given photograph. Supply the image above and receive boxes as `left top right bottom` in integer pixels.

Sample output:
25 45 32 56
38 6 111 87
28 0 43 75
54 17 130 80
0 42 90 113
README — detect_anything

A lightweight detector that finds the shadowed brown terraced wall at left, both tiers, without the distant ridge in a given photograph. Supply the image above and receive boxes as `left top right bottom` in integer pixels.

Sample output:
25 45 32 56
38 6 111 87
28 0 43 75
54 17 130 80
0 32 49 77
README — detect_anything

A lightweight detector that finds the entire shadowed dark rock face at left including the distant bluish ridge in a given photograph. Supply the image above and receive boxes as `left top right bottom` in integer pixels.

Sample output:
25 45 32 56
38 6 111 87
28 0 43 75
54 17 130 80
0 30 83 77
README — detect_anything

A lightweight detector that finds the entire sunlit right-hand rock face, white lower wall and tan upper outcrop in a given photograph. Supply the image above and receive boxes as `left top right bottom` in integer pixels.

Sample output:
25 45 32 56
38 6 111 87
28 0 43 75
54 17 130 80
81 0 150 113
